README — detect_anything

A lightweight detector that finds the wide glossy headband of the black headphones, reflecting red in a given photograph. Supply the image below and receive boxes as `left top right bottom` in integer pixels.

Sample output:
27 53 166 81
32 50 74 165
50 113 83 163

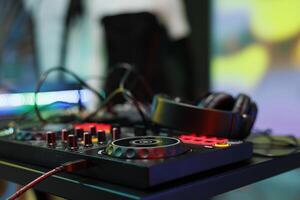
152 96 252 139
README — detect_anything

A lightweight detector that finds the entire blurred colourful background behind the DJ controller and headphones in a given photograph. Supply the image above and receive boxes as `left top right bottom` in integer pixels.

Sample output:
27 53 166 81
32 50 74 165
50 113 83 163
0 0 300 199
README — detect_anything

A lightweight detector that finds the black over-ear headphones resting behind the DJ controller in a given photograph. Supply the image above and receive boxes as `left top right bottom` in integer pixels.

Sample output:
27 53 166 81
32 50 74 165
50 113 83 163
151 92 257 140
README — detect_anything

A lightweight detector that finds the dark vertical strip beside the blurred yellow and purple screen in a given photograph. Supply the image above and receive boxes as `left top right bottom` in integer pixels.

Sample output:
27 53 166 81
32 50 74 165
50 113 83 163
184 0 213 98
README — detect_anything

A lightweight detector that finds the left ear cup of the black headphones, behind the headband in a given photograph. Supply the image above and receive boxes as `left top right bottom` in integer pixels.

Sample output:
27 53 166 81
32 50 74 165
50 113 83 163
199 92 234 111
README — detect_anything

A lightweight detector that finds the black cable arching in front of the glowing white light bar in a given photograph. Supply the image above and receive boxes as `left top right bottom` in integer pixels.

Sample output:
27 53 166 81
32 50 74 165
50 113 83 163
34 67 105 123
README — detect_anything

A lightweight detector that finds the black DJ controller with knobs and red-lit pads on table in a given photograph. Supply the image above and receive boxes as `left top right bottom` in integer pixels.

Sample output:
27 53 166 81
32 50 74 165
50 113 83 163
0 123 252 188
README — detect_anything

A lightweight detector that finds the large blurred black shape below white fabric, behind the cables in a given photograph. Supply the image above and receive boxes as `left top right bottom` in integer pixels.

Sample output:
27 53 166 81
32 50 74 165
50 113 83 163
102 12 198 100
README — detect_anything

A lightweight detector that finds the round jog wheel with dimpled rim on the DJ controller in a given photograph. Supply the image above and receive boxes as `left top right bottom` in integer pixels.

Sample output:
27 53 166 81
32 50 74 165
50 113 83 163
105 136 189 159
